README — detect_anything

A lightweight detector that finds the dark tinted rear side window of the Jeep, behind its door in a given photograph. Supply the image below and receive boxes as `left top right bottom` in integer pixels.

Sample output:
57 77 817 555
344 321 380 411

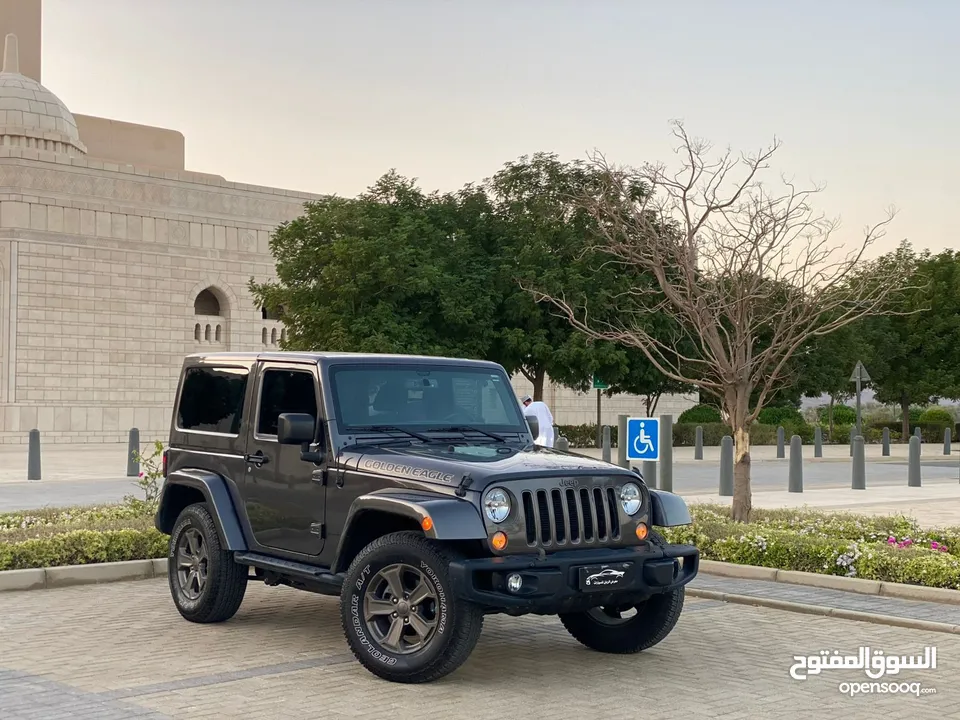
177 367 248 435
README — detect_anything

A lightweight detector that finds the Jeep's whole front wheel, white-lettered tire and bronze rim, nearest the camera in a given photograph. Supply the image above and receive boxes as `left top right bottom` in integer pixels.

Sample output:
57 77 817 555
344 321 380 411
340 532 483 683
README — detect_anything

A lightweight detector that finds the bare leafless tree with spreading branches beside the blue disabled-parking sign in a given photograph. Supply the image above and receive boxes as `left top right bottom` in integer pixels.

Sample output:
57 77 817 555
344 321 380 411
528 123 904 521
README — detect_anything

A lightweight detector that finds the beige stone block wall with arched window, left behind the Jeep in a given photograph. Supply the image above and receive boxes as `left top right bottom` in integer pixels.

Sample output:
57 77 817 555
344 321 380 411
0 149 315 444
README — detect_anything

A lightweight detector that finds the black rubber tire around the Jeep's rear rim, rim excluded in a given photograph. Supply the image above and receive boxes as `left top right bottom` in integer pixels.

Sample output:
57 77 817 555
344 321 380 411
167 503 249 623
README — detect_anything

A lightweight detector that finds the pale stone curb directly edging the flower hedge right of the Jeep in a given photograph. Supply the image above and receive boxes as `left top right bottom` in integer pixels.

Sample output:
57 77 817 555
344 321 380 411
700 560 960 605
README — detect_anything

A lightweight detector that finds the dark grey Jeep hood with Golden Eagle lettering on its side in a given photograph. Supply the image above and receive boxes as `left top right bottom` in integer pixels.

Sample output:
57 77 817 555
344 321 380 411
339 443 637 490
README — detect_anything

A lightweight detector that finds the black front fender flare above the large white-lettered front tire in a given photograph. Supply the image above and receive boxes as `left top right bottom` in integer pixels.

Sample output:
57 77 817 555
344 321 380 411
337 489 487 562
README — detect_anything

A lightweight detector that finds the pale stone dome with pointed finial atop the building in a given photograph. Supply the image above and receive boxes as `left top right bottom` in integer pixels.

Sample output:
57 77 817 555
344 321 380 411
0 35 87 156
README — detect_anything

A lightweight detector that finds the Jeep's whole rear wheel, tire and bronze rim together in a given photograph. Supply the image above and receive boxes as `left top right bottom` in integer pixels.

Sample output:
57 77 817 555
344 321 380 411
167 503 249 623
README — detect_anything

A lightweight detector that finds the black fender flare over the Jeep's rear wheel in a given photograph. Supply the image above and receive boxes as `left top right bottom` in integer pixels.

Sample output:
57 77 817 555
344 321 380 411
155 468 248 551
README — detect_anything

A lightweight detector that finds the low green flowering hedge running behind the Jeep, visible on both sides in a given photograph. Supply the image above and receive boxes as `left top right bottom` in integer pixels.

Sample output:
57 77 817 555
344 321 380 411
7 504 960 589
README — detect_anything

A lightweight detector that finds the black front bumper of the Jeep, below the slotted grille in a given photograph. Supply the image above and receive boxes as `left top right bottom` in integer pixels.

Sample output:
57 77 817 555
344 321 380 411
450 545 700 614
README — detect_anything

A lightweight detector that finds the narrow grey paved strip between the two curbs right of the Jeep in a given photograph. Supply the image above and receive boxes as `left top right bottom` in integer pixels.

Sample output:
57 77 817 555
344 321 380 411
690 573 960 625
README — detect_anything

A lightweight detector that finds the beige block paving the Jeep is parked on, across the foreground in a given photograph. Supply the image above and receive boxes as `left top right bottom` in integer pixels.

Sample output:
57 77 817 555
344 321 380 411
0 579 960 720
